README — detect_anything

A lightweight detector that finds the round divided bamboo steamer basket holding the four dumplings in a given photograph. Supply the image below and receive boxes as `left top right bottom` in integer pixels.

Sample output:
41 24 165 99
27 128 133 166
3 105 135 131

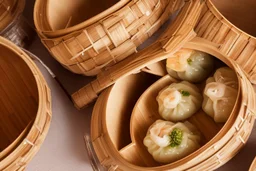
88 43 256 171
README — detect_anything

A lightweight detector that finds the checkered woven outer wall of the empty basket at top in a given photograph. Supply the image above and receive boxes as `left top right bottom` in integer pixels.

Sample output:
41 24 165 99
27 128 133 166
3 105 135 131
39 0 183 75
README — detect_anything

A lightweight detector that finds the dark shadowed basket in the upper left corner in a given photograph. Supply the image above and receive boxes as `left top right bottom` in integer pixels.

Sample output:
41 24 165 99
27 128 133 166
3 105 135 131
0 0 34 47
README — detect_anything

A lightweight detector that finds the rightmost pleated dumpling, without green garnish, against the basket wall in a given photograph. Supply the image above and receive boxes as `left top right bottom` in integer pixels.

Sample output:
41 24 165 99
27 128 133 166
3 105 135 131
202 67 238 122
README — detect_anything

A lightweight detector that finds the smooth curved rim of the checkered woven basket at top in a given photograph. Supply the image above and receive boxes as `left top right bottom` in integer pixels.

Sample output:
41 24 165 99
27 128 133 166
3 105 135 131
34 0 130 38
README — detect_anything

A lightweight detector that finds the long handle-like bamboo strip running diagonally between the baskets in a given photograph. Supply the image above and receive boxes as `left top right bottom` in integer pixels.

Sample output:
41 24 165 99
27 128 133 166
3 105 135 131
72 1 203 108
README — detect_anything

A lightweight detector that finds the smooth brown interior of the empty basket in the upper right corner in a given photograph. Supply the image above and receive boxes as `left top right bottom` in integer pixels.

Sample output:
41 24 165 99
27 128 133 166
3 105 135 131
212 0 256 37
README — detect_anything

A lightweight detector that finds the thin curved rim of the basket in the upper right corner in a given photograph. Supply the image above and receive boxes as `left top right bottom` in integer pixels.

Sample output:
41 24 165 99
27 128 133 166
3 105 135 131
206 0 256 39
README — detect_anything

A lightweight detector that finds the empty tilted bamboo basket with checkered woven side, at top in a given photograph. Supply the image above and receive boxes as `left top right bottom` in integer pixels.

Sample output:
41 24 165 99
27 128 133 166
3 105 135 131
34 0 184 76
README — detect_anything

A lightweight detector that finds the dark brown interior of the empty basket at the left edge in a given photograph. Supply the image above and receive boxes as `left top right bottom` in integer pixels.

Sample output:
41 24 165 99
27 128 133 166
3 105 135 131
0 45 39 153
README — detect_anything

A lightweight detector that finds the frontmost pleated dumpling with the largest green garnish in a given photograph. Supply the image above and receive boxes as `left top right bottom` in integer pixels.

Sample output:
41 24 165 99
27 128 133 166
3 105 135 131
143 120 201 163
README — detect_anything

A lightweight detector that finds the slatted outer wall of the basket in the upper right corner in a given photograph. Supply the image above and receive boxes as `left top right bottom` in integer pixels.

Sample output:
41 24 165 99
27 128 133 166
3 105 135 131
195 1 256 83
